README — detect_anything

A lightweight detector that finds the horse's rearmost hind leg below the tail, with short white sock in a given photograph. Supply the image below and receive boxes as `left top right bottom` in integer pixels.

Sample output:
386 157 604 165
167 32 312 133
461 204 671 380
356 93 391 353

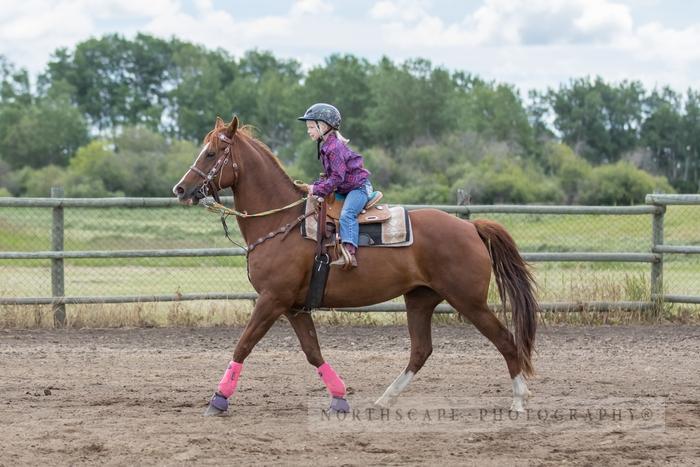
460 303 530 412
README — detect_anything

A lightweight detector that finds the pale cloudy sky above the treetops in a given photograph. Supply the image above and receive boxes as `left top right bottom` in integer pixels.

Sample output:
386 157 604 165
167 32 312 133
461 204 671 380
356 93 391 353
0 0 700 92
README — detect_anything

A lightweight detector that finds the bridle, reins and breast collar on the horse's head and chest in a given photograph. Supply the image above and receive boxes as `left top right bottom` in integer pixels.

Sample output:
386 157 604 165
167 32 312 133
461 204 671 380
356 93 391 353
190 133 314 255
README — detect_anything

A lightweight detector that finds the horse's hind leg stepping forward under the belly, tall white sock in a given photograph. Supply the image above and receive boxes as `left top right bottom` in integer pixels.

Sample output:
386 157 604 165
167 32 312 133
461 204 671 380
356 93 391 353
375 287 442 407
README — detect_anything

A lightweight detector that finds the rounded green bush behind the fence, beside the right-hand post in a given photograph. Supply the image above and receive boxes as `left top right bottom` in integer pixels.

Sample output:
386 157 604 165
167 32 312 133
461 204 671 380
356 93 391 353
581 161 674 205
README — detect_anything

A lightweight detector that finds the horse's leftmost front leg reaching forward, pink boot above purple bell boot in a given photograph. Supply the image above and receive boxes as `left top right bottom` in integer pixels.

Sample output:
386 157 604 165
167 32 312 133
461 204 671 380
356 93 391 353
204 294 289 416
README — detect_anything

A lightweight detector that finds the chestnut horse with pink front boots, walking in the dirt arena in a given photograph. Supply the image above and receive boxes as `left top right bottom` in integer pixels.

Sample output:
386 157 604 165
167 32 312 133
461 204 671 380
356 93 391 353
173 116 537 415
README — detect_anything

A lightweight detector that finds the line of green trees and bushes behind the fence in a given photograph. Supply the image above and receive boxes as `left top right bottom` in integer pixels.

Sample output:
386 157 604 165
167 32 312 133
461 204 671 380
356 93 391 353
0 34 700 204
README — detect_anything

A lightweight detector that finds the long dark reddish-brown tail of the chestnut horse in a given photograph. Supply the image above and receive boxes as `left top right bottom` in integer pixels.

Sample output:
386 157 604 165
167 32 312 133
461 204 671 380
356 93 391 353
472 219 538 376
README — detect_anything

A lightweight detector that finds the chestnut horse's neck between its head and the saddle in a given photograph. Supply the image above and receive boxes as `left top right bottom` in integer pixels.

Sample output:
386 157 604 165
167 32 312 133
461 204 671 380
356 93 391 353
233 141 301 244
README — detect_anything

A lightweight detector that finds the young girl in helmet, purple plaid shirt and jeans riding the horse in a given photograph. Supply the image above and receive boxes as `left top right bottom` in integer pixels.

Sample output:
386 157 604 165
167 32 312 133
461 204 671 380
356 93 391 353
298 103 372 269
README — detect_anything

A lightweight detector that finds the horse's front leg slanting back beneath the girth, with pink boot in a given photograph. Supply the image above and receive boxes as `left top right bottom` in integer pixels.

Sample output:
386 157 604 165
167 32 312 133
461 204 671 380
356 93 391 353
287 312 350 412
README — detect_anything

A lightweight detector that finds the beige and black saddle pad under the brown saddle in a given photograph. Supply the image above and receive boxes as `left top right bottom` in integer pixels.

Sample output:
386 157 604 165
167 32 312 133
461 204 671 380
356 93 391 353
301 200 413 247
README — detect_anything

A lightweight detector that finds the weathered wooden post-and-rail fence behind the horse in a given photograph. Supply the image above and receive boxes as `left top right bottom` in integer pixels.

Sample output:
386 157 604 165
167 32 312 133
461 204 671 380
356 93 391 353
0 188 700 325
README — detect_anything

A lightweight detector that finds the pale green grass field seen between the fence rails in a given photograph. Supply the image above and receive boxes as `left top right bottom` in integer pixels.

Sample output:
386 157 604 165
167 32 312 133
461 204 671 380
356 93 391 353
0 206 700 324
